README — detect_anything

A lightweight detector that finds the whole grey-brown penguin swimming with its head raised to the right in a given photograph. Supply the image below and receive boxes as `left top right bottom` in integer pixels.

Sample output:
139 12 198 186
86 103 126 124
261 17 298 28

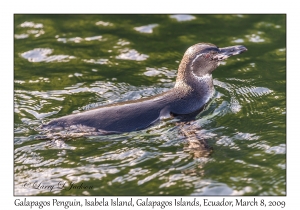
42 43 247 156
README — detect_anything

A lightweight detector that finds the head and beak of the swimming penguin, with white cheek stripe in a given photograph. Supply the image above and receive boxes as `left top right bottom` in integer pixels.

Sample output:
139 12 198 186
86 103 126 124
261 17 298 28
178 43 247 78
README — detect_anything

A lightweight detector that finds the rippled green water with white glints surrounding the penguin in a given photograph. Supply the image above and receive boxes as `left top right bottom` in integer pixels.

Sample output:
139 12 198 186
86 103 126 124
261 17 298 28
14 15 286 196
